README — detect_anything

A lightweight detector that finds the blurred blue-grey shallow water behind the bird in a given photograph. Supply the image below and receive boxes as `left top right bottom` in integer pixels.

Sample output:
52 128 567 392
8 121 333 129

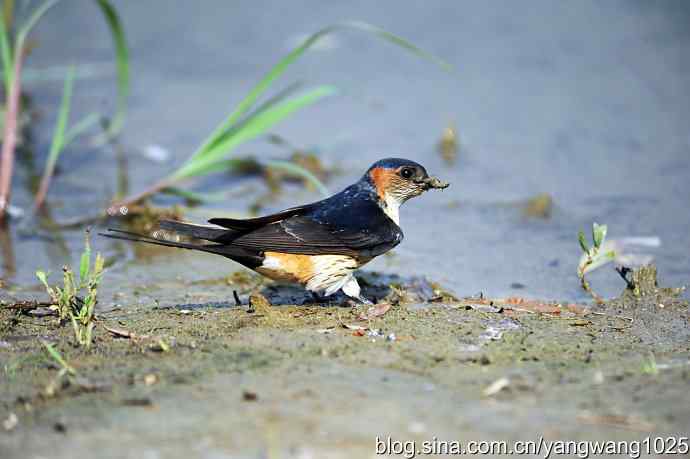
2 0 690 301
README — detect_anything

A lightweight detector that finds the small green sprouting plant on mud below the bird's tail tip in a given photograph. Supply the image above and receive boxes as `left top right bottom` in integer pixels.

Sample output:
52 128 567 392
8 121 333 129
36 231 104 348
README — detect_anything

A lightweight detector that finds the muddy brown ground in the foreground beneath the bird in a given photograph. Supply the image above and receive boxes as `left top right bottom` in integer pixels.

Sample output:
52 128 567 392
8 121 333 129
0 273 690 458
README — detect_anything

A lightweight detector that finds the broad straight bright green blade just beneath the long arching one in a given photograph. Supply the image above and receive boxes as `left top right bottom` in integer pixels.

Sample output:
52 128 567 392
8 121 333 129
170 86 335 181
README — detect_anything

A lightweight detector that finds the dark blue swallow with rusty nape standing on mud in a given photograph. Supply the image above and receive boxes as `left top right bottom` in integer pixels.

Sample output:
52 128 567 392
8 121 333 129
101 158 449 305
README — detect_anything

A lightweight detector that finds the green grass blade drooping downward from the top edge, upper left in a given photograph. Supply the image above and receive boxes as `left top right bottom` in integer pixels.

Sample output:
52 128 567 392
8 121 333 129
96 0 129 142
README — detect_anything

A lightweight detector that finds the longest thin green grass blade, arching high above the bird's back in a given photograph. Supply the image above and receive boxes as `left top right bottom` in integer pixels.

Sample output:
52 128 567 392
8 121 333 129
192 21 454 165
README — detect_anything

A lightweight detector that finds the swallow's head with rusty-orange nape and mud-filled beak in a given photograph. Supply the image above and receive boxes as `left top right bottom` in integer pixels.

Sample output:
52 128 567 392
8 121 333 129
364 158 448 205
